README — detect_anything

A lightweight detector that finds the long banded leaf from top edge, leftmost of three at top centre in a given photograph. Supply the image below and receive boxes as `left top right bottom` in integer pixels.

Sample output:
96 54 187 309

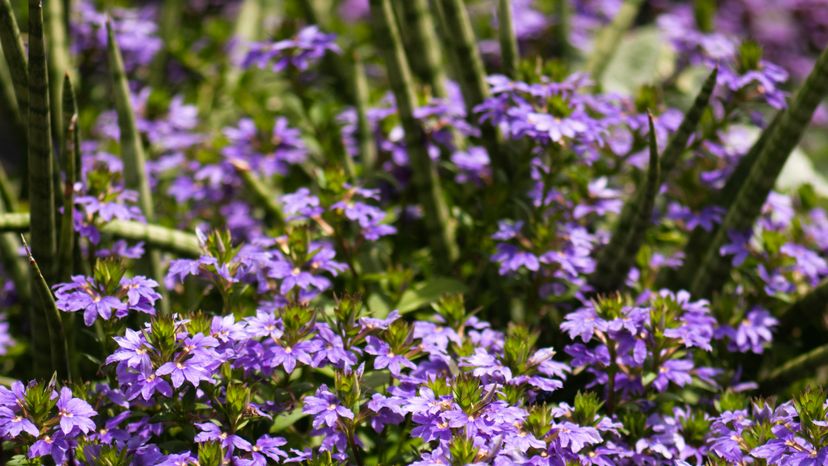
371 0 459 270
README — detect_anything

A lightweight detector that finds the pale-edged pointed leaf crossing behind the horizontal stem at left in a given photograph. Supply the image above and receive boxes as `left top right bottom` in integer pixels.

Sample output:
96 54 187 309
106 20 166 308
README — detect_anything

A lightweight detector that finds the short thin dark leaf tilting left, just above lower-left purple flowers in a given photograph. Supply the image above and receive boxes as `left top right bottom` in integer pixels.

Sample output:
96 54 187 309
20 235 71 380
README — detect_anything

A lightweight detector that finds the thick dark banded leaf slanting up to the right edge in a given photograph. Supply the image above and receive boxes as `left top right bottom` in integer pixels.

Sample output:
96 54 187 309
690 44 828 297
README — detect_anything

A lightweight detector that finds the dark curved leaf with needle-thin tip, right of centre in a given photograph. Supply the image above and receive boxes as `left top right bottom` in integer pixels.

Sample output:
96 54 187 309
592 115 661 292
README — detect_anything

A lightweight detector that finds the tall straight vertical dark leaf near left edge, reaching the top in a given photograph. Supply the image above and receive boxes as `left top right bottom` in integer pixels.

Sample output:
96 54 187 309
28 0 57 377
